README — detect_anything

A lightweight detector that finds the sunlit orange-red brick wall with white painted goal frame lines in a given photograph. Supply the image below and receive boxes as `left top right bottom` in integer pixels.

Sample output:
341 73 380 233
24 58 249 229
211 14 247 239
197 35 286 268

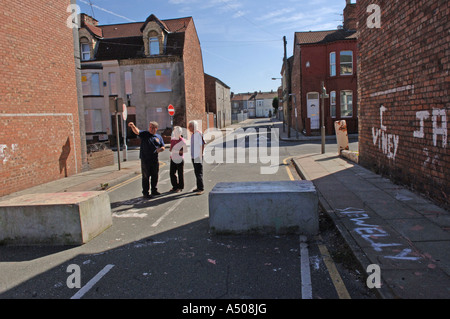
0 0 81 196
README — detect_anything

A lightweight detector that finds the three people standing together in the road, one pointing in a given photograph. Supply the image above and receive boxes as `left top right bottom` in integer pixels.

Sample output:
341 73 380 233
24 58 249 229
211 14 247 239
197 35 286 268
128 121 205 198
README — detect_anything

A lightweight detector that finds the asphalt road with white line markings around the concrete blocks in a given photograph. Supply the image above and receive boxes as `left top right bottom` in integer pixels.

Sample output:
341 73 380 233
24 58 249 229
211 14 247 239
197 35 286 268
0 120 375 313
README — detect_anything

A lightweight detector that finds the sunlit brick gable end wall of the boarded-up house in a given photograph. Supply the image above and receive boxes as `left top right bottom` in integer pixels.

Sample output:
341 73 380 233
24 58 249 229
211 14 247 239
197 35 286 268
183 20 207 131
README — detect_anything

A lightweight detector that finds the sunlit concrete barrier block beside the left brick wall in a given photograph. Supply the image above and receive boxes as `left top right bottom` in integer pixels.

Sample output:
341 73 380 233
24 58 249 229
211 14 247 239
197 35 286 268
0 192 112 245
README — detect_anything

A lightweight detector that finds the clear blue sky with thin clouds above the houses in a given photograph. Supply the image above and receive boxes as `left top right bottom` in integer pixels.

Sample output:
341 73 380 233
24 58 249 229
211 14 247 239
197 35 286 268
77 0 355 94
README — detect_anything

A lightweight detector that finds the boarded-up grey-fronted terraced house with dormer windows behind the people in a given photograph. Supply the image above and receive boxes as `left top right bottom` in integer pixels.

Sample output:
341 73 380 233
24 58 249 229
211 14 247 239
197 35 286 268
79 14 207 145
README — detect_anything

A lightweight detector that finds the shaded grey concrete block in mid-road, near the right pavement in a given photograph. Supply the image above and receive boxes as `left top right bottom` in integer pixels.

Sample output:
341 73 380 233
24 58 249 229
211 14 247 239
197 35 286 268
209 181 319 235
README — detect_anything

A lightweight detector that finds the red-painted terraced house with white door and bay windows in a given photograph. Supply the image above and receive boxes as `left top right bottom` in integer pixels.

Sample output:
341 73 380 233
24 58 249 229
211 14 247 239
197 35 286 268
285 0 358 135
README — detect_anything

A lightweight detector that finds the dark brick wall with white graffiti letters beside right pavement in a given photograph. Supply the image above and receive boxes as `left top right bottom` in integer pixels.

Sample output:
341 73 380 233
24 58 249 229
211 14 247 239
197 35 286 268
357 0 450 207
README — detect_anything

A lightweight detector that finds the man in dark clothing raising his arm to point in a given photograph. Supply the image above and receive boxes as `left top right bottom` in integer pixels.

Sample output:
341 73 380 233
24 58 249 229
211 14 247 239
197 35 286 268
128 122 165 198
